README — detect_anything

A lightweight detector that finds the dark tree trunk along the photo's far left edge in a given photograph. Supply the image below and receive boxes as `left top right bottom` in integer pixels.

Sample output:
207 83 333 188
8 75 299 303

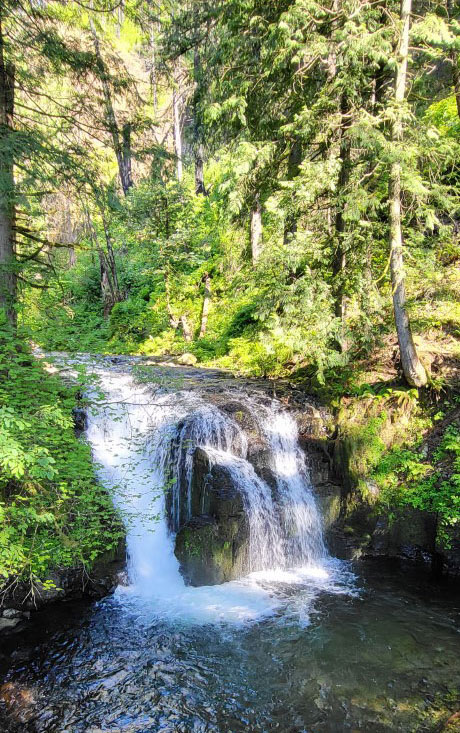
0 15 17 327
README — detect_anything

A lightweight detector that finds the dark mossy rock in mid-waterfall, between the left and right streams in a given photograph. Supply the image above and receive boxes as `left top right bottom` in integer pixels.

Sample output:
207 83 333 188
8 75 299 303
175 448 249 585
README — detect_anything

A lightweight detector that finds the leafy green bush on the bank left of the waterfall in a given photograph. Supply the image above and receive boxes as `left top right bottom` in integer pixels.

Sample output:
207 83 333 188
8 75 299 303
0 327 122 587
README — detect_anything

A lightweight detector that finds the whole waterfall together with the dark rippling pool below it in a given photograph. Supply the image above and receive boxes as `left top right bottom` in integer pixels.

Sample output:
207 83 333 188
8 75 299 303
0 360 460 733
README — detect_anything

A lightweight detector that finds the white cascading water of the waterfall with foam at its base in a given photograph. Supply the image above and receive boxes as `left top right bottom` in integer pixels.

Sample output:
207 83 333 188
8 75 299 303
83 368 348 623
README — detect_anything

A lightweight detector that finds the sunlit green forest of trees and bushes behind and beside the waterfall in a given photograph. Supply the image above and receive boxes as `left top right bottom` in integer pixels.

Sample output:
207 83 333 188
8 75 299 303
0 0 460 578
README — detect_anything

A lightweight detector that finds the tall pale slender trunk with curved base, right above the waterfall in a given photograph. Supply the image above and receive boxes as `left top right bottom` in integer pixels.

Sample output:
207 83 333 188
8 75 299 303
388 0 427 387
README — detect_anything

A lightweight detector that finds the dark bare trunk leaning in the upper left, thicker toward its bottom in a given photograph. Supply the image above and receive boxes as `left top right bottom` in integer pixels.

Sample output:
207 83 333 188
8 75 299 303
90 18 133 196
